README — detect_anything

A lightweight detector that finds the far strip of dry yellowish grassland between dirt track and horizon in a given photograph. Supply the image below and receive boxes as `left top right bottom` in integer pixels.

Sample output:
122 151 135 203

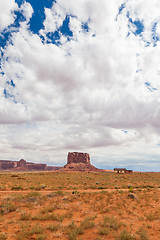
0 172 160 191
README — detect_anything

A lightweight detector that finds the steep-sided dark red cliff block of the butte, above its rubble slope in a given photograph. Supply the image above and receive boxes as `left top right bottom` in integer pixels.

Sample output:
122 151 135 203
67 152 90 164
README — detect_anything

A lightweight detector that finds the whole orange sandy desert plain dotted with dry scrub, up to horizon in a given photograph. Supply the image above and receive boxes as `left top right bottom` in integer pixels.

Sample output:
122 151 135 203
0 171 160 240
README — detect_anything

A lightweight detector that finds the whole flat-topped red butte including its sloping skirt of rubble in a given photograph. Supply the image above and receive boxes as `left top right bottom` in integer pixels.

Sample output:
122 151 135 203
60 152 101 172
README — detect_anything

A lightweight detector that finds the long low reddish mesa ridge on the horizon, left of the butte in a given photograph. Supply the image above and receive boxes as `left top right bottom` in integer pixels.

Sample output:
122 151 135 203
0 159 60 171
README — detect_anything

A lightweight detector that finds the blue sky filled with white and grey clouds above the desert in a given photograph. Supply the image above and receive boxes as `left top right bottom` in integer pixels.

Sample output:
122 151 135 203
0 0 160 171
